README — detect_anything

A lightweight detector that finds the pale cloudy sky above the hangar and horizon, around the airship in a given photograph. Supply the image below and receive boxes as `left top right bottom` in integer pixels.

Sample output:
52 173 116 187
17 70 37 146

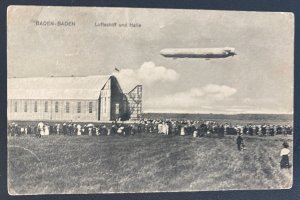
7 6 294 114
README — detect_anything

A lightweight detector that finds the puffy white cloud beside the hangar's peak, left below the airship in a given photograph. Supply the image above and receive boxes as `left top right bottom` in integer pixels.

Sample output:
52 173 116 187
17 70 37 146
114 62 179 91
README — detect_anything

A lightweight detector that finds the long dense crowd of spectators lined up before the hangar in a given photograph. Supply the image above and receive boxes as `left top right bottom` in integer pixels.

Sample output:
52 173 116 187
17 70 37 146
8 120 293 137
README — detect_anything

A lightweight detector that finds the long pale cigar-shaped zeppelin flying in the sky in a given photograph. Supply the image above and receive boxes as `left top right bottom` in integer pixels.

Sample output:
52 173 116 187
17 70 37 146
160 47 236 59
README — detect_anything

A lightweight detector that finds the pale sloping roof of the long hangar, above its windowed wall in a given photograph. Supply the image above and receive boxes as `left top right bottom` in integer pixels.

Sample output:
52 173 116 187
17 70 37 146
7 75 111 100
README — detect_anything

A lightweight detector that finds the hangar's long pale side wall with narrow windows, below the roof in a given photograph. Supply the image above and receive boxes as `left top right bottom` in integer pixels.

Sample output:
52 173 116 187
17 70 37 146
7 99 98 122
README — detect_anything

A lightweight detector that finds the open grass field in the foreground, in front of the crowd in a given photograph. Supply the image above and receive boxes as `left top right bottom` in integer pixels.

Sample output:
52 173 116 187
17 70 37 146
8 134 293 194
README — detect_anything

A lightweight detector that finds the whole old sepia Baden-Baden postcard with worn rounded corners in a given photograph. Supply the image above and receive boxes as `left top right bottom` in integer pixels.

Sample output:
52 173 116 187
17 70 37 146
7 5 295 195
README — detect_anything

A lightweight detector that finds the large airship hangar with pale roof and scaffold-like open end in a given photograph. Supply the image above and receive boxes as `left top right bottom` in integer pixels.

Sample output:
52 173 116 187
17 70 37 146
7 76 142 122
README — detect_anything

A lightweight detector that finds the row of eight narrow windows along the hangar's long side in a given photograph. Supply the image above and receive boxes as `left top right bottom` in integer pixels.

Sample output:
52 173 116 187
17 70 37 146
14 101 93 113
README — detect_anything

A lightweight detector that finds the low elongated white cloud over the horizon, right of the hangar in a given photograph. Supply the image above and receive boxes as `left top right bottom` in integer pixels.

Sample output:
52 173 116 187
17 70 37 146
144 84 237 112
